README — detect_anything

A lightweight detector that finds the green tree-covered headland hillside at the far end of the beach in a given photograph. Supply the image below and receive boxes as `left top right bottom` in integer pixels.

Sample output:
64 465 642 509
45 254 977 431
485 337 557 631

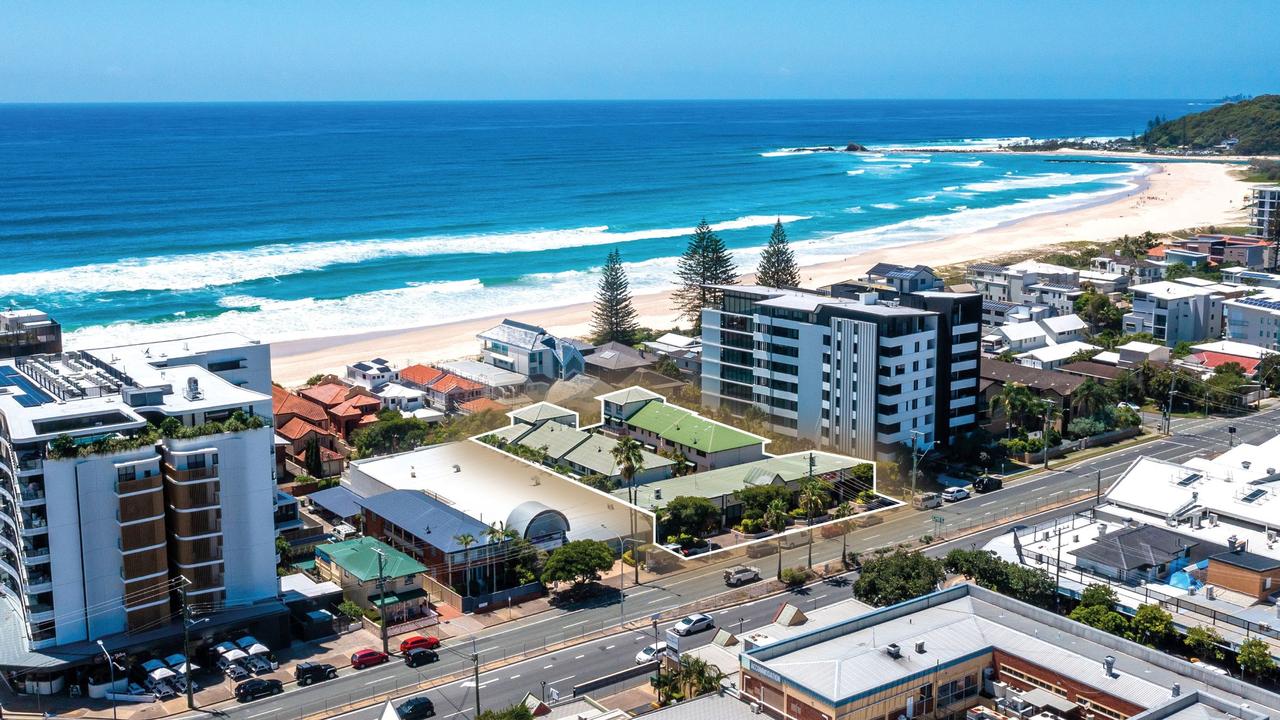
1140 95 1280 155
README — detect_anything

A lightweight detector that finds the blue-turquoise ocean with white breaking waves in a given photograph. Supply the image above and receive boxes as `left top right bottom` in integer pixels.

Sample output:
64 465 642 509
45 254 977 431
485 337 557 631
0 100 1203 346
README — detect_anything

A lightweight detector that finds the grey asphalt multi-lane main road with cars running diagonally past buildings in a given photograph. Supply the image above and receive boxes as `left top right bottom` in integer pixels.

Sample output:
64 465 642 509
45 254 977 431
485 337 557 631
188 407 1280 720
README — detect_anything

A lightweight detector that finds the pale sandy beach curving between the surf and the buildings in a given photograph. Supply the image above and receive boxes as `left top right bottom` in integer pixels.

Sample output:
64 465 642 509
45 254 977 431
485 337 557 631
262 161 1251 387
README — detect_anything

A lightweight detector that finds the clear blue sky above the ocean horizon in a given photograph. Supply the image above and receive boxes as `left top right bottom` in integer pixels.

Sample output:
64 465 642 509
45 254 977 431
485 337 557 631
0 0 1280 102
